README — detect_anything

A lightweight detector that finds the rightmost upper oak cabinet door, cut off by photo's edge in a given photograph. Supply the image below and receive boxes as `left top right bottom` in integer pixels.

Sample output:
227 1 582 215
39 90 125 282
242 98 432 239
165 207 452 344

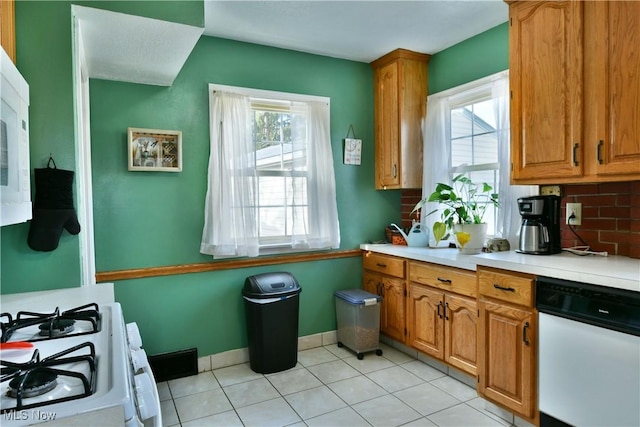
585 1 640 179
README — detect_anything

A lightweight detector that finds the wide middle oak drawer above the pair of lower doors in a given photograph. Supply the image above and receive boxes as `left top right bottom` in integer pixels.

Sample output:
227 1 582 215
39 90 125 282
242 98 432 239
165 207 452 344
409 262 477 298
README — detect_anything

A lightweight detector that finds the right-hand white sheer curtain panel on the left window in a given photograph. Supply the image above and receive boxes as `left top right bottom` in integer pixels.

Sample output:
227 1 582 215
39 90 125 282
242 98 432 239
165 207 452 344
291 101 340 249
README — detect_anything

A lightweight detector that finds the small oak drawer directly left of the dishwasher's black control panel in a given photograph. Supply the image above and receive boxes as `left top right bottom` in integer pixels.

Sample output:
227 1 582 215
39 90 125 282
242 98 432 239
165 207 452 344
478 267 534 307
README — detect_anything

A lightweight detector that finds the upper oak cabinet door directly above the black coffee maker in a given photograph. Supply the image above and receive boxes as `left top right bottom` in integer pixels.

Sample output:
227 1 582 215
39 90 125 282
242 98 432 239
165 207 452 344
509 1 584 183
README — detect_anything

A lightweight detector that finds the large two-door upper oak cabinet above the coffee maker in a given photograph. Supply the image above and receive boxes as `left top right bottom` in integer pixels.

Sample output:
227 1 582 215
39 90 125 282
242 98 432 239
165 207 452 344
508 0 640 184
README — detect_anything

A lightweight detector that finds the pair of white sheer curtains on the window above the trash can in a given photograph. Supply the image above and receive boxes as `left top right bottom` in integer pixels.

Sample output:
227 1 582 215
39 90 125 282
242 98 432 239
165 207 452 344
200 88 340 258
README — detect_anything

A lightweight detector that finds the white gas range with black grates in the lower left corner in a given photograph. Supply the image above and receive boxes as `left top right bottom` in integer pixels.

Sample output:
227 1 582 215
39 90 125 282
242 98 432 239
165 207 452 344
0 285 162 427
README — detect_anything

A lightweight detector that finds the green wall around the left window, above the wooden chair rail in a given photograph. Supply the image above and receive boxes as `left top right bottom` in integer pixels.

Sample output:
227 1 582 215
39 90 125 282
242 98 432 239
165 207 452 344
90 37 390 271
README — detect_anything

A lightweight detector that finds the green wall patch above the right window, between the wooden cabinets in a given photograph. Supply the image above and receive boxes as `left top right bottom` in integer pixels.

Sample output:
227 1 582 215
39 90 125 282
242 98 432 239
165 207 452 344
429 22 509 94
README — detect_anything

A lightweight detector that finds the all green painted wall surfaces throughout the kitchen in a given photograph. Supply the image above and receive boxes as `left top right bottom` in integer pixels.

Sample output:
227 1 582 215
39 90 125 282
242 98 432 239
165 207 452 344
0 1 508 355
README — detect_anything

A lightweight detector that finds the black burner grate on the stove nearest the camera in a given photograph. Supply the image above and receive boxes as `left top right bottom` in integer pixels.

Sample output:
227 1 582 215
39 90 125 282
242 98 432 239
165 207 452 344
0 342 97 414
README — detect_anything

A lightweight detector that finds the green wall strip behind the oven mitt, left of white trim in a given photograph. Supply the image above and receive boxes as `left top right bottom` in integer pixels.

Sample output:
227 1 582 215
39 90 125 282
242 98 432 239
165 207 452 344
0 1 80 293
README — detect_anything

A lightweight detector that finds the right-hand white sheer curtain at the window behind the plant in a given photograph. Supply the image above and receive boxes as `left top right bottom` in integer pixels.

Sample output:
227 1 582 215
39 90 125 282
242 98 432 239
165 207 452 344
491 73 538 248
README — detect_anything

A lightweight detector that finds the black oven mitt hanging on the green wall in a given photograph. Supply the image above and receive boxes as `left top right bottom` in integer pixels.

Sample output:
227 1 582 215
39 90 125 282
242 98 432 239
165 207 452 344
27 158 80 252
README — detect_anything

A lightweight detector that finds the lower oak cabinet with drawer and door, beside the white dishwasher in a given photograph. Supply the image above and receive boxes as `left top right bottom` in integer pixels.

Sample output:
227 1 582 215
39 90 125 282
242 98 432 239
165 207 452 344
477 267 538 424
